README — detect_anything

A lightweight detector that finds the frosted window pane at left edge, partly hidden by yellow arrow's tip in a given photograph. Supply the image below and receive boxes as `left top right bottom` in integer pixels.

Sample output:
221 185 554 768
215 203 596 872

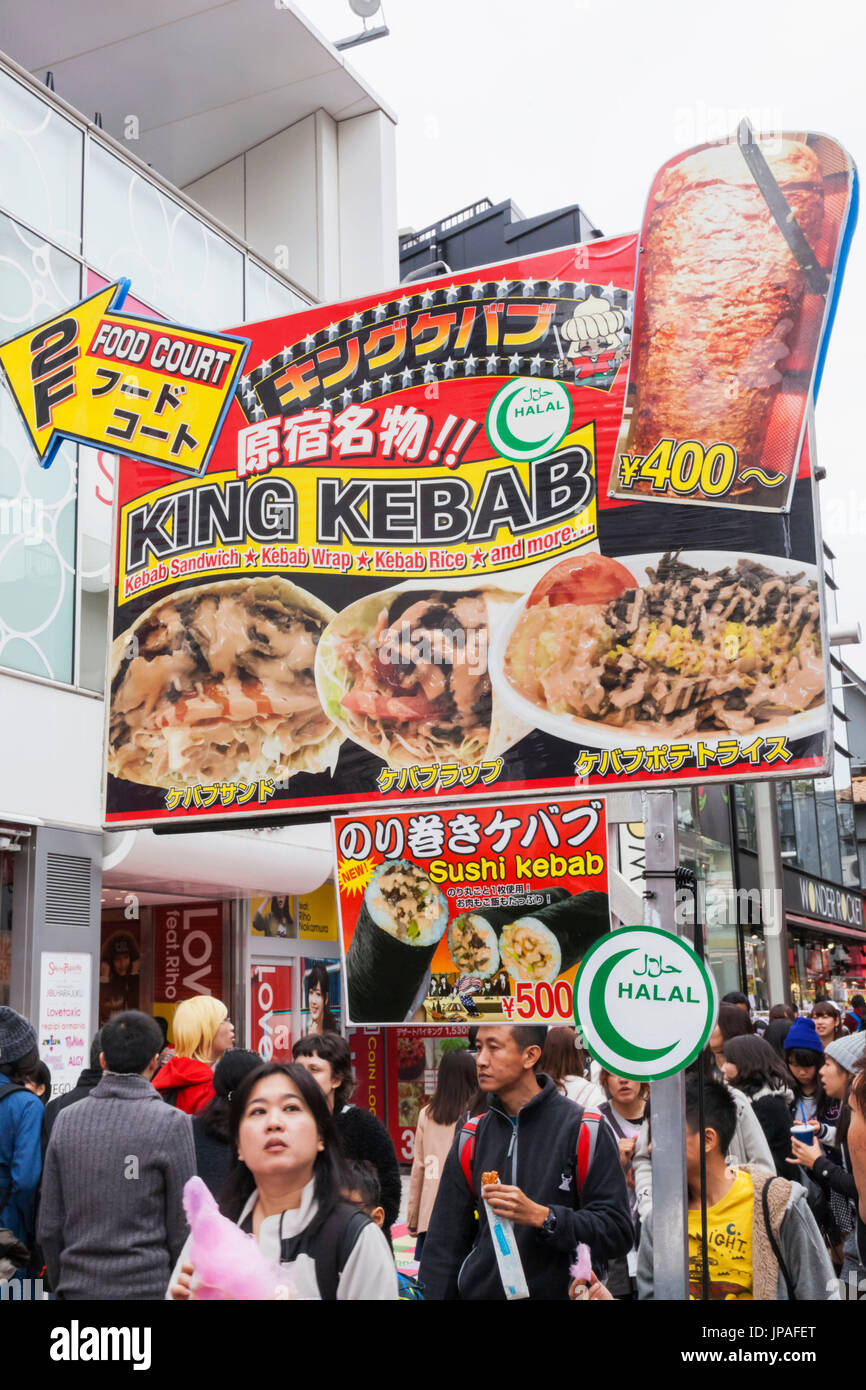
0 215 81 684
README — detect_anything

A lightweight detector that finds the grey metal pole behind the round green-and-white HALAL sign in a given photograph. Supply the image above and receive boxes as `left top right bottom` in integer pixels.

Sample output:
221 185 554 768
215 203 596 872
644 791 688 1300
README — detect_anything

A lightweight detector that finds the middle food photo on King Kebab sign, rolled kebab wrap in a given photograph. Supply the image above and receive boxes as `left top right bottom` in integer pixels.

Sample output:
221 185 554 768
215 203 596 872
316 584 531 767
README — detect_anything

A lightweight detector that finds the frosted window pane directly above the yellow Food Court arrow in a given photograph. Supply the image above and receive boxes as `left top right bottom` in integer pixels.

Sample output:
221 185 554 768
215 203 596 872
85 139 243 328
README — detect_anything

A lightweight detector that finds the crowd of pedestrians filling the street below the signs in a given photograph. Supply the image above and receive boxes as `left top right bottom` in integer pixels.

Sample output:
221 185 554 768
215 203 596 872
0 995 866 1301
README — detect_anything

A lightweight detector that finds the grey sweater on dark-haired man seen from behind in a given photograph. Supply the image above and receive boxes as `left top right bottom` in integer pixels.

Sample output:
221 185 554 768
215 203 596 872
39 1072 196 1300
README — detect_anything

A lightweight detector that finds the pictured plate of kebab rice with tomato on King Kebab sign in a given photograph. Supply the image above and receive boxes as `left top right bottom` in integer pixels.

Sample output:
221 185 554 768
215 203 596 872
491 550 826 746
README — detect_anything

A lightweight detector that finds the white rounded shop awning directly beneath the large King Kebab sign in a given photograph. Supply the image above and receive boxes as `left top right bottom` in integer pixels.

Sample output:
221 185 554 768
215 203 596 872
103 824 332 898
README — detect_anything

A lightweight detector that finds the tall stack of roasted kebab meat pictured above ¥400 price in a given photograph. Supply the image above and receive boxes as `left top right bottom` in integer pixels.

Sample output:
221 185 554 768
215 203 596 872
612 138 824 500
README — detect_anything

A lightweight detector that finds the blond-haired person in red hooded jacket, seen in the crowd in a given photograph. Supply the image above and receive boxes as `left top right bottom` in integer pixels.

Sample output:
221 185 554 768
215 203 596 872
153 994 235 1115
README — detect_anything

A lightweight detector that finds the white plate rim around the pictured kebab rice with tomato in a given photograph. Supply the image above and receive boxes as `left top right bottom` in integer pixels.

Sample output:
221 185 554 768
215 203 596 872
489 550 827 748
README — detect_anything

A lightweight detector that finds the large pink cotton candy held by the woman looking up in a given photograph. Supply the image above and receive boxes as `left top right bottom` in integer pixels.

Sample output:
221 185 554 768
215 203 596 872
183 1177 286 1300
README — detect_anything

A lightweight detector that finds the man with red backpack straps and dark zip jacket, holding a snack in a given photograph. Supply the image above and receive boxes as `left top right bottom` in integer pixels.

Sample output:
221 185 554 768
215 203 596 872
418 1024 634 1300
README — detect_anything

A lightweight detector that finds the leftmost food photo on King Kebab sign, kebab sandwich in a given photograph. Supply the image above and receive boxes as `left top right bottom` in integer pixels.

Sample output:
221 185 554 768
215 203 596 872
108 577 342 787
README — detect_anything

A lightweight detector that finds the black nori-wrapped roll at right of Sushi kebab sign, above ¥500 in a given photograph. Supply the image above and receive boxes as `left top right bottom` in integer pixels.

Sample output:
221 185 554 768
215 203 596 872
499 888 610 984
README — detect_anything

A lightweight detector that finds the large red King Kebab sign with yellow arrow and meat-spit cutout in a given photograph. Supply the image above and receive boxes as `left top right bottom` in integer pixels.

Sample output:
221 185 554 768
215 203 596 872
0 132 855 828
